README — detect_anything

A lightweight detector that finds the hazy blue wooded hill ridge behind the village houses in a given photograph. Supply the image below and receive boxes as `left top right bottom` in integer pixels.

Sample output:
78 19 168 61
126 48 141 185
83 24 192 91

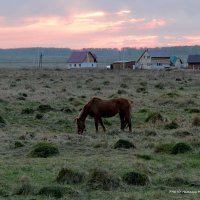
0 46 200 67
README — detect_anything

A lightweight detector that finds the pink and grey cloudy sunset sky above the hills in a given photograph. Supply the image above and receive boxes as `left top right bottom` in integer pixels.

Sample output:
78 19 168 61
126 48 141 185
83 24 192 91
0 0 200 49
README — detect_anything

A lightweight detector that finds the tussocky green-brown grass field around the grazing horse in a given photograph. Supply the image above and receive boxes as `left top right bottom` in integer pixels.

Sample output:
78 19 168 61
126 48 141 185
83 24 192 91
0 69 200 200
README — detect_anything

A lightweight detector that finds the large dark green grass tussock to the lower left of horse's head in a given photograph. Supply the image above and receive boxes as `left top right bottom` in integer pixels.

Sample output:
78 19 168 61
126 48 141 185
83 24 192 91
30 142 59 158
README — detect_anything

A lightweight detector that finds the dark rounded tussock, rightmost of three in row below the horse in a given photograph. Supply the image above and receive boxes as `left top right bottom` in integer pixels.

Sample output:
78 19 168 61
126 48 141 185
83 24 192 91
122 172 149 186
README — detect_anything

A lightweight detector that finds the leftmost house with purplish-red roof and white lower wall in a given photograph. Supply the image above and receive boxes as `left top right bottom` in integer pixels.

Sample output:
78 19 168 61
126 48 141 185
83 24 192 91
67 51 97 69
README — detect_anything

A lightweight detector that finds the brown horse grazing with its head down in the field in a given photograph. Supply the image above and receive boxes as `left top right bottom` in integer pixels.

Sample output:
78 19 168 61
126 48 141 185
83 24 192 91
76 97 132 134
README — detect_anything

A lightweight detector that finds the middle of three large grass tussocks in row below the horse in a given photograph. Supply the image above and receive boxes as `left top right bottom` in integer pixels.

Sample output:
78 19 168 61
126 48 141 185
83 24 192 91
87 169 120 190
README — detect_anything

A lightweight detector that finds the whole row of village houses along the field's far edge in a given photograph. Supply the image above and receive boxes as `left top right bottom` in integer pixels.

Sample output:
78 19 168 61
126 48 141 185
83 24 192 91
67 49 200 70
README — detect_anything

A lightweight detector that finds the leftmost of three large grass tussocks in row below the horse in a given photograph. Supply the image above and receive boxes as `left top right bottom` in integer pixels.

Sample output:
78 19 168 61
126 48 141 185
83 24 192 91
56 168 85 184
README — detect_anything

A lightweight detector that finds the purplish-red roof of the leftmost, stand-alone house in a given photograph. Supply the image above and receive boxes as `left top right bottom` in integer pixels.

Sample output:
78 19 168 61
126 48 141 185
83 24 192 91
67 51 97 63
